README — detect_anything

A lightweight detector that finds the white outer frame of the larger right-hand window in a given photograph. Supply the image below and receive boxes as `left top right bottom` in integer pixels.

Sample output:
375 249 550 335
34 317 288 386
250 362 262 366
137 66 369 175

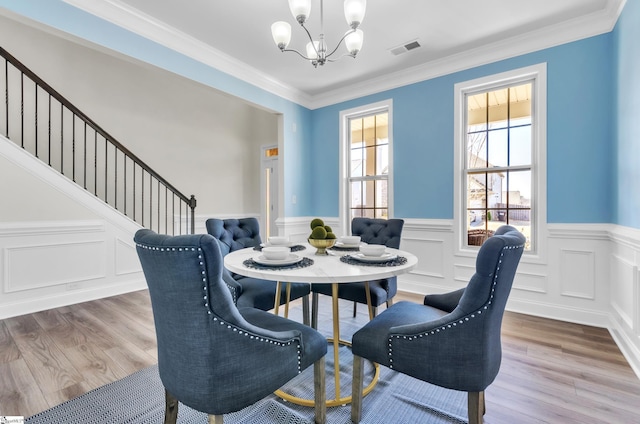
453 63 547 261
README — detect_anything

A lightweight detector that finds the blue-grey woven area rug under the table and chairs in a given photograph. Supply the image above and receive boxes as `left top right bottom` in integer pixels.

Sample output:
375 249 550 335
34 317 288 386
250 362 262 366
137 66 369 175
25 304 467 424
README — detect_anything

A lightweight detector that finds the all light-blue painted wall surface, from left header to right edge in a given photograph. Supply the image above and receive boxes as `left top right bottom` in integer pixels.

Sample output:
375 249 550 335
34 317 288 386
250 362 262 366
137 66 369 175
0 0 640 228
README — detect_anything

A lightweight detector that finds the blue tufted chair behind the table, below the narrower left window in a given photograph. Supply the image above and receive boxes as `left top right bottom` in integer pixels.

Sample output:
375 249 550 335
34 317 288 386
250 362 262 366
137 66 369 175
311 218 404 328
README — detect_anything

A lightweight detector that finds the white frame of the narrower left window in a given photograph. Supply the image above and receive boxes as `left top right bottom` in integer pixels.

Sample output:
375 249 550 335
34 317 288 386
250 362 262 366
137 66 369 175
338 99 393 234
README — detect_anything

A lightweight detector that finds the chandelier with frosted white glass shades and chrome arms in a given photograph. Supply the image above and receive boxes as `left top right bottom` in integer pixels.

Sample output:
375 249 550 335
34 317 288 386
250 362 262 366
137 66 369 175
271 0 367 68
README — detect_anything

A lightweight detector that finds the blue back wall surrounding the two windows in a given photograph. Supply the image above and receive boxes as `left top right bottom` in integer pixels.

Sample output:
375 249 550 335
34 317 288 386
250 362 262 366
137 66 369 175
310 34 614 223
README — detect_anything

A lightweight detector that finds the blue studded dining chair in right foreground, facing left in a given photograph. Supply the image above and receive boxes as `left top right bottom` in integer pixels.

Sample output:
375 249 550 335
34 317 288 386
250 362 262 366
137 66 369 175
351 225 525 424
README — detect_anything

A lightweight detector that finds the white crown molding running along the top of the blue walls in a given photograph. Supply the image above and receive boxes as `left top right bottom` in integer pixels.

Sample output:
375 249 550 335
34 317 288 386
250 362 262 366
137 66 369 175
63 0 626 109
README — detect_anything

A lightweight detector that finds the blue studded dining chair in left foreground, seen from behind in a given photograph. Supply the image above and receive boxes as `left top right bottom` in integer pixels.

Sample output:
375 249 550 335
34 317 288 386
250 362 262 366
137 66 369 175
134 229 327 424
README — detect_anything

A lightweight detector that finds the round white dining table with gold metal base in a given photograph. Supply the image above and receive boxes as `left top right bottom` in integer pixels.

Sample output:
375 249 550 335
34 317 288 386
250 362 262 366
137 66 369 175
224 243 418 406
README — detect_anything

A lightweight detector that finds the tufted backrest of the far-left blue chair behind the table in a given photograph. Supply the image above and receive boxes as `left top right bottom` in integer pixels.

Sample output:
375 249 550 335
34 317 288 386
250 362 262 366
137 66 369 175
205 217 262 256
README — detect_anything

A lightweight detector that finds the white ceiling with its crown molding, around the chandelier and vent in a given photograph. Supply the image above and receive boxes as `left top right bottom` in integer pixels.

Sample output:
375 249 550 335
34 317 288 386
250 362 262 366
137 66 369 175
65 0 625 107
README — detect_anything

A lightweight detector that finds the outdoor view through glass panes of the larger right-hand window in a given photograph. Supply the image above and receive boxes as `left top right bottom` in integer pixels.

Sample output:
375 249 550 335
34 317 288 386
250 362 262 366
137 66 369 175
465 82 533 249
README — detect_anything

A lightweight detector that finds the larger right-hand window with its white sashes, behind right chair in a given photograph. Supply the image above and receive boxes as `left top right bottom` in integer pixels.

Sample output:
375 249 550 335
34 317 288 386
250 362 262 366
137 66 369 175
456 64 544 252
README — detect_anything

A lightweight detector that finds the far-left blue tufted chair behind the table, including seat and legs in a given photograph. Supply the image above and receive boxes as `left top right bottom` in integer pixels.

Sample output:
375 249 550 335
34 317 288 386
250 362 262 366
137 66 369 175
205 218 311 324
